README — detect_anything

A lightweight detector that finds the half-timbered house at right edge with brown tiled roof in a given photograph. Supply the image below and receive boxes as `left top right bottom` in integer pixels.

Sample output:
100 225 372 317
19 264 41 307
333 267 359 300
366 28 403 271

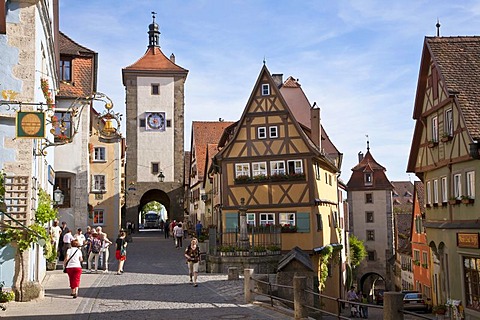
407 36 480 319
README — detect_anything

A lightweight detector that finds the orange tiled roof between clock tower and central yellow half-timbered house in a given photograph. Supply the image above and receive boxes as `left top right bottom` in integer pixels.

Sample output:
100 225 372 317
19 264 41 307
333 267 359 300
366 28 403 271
190 121 233 181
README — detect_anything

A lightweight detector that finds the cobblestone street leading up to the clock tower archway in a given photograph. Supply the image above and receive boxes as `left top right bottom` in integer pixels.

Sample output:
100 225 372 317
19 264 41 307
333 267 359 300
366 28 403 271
0 232 292 320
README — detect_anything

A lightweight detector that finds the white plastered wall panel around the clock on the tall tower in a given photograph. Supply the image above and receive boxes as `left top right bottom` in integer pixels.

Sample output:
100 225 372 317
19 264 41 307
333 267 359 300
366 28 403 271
137 77 174 182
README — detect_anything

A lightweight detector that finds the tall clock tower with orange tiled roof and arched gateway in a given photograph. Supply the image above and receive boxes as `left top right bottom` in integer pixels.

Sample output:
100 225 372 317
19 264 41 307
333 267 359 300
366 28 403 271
122 12 188 228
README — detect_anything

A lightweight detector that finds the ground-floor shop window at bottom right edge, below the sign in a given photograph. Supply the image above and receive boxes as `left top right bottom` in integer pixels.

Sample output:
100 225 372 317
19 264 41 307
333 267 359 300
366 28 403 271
463 257 480 310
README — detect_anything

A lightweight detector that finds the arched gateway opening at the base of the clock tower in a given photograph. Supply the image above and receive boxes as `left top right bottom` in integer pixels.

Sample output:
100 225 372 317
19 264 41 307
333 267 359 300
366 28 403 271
136 189 171 231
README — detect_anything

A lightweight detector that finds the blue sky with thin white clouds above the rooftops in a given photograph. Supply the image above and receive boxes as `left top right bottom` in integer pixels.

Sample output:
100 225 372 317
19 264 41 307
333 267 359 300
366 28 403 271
60 0 480 182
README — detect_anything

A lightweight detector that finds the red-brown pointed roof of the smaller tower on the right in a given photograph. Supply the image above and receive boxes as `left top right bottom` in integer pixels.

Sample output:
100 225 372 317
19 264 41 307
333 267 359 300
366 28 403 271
347 150 394 191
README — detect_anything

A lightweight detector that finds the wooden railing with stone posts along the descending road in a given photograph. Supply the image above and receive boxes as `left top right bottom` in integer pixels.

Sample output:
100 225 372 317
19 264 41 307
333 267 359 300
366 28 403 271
244 269 432 320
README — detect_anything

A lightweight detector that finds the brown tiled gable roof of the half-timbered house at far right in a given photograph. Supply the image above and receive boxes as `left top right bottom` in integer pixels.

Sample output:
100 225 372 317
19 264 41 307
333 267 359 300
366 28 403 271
407 36 480 172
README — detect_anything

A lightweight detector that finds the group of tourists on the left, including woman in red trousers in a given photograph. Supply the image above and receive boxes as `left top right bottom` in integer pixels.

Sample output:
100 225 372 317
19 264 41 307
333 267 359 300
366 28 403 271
50 221 128 298
